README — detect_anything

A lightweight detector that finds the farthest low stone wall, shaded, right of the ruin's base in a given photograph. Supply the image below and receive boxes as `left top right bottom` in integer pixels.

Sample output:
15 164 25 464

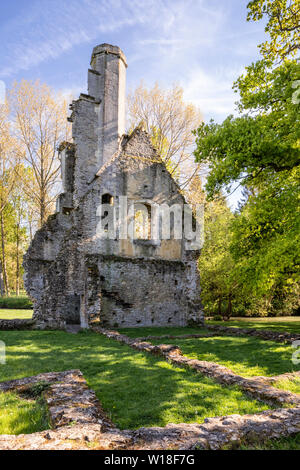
205 324 300 344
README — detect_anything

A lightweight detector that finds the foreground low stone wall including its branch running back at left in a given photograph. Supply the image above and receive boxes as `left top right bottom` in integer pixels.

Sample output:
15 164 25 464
0 368 300 450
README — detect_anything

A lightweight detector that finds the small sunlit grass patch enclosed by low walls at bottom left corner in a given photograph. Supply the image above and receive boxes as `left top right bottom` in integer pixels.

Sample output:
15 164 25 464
0 393 50 434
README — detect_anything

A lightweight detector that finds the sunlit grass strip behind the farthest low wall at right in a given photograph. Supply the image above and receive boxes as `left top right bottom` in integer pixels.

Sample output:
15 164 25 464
207 317 300 334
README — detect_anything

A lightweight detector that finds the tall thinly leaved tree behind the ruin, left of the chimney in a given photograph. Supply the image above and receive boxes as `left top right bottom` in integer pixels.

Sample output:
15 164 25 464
9 80 69 225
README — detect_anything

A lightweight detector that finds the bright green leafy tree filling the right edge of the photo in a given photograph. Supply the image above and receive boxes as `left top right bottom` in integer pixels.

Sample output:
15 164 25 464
195 0 300 314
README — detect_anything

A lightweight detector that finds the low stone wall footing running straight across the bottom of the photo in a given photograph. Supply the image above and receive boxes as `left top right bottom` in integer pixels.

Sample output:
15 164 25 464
0 408 300 450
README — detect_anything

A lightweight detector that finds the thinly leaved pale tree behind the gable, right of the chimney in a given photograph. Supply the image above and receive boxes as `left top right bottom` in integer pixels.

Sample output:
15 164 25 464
127 83 202 189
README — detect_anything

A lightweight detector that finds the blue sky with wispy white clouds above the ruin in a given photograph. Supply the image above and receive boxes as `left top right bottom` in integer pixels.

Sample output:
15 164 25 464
0 0 265 206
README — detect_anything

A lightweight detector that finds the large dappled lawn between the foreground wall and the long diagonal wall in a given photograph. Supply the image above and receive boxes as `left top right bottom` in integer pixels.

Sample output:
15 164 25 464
0 331 268 429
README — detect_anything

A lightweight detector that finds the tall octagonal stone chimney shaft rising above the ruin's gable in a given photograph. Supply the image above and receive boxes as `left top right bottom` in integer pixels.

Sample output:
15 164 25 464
88 44 127 164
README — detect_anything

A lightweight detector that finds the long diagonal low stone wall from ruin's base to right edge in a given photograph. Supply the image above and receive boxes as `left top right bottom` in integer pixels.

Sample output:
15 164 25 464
94 328 300 406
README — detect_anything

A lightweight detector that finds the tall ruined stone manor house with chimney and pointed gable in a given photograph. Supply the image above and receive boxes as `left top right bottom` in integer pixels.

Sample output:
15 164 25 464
24 44 203 329
